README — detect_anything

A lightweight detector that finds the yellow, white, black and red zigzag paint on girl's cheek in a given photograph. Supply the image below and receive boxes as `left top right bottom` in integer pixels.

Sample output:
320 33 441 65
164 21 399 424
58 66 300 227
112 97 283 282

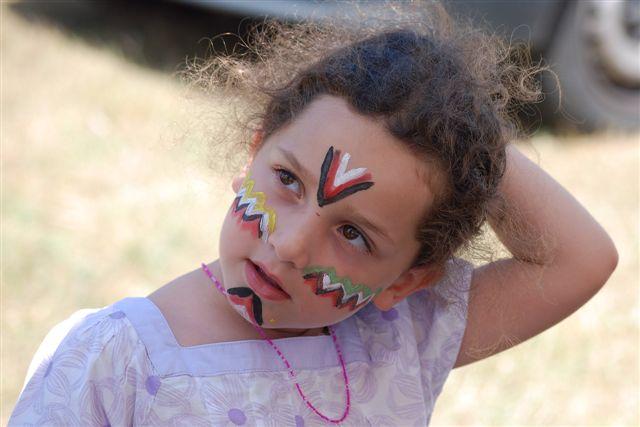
231 175 276 243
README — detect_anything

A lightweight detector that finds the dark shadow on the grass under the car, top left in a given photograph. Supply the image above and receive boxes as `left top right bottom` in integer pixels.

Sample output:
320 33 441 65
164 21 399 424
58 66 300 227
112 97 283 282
10 0 255 73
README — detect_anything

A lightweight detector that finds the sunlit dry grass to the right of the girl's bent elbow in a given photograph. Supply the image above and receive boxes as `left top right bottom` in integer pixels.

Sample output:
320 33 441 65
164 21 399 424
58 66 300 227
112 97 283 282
432 135 640 426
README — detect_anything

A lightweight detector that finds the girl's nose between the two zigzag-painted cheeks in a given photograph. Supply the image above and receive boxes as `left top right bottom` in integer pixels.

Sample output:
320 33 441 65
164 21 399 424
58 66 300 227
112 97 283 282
269 213 317 269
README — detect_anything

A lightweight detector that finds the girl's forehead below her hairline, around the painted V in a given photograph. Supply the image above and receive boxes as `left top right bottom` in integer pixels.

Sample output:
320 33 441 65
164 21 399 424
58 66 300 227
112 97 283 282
263 97 433 244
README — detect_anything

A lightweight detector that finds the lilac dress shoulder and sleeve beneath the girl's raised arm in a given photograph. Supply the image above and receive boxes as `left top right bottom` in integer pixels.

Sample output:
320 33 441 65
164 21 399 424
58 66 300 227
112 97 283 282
356 258 474 397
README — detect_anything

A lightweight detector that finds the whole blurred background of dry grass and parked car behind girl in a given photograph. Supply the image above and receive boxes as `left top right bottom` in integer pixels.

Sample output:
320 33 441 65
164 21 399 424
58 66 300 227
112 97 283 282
0 0 640 426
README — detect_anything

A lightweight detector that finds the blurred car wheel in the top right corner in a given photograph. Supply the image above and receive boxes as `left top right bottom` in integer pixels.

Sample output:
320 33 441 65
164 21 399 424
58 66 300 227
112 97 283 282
542 1 640 132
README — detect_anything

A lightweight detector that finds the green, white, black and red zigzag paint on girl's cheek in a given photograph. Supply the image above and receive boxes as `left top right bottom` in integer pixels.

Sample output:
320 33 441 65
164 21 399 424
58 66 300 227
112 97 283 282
302 267 381 310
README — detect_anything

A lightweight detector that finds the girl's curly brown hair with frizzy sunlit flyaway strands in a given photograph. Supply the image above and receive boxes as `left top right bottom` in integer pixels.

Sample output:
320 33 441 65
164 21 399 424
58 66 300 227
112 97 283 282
186 2 541 278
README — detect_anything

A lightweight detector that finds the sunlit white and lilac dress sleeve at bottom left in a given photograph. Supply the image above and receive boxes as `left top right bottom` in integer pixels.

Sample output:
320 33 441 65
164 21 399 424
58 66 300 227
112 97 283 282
8 307 149 426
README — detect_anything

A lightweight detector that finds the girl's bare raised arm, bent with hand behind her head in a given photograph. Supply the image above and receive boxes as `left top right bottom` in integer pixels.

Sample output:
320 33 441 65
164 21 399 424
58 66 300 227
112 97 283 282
455 145 618 367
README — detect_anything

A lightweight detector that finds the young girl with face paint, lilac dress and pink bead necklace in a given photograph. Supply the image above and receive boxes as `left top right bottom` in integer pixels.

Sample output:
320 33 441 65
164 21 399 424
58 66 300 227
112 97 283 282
9 4 617 426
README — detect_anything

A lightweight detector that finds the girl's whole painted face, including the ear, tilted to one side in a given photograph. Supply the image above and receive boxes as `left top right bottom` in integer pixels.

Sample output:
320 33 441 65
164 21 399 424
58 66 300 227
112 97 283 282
220 96 433 329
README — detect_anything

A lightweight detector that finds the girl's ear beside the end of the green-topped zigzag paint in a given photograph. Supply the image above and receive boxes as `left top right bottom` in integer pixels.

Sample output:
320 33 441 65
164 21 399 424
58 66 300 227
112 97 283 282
373 265 444 311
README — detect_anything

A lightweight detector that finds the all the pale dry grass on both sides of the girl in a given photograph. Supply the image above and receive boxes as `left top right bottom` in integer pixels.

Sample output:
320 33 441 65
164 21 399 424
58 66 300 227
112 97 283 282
0 4 640 425
